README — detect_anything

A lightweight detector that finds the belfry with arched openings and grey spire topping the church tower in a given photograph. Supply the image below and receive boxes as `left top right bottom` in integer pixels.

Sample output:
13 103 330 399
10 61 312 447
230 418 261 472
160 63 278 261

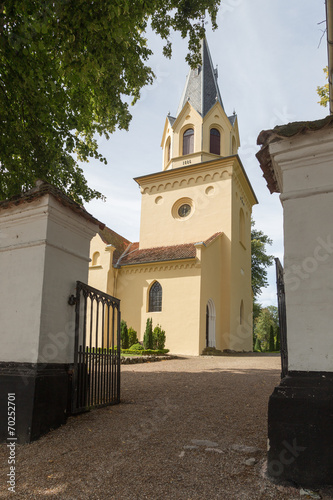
161 38 240 170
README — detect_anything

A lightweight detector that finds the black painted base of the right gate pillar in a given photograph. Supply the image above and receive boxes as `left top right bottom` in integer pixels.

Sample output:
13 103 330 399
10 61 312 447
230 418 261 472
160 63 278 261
267 372 333 486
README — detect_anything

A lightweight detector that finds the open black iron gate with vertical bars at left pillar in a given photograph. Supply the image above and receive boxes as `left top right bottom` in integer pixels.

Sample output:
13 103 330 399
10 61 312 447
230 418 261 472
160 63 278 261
72 281 120 413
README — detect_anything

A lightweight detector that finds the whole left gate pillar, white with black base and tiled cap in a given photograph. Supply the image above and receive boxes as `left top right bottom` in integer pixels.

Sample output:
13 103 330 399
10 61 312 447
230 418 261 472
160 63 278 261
0 181 103 443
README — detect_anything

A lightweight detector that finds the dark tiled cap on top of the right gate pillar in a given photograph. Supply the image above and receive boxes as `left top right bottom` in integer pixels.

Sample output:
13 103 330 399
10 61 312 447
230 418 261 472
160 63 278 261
256 115 333 193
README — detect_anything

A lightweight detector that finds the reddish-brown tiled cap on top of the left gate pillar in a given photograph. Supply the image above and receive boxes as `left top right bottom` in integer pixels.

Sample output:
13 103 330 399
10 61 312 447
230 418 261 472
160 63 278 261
0 179 105 230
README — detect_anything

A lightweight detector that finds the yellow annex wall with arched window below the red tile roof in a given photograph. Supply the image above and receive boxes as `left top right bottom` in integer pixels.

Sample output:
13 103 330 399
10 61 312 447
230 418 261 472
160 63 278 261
117 261 201 355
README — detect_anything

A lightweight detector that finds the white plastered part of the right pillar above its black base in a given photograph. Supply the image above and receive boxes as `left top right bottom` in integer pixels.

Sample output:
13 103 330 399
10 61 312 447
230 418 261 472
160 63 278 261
270 129 333 372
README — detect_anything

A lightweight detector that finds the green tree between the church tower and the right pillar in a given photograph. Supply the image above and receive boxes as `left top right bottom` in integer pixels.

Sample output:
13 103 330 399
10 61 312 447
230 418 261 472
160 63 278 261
251 220 274 298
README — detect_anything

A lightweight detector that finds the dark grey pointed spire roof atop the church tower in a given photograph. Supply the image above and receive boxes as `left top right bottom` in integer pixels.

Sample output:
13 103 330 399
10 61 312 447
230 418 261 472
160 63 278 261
177 38 224 117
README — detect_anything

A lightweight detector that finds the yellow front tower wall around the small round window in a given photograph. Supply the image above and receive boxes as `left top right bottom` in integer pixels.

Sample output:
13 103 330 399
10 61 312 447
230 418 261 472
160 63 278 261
137 157 236 248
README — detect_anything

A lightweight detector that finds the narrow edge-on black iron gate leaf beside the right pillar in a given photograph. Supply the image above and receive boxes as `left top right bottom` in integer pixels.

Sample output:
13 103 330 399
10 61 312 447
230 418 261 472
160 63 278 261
275 258 288 378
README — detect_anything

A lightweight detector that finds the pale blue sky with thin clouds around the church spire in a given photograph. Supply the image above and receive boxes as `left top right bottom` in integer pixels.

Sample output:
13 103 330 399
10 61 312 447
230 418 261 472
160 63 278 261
81 0 329 306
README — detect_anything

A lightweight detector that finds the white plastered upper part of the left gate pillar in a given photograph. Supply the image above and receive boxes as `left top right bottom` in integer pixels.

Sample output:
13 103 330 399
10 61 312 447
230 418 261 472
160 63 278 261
0 195 97 363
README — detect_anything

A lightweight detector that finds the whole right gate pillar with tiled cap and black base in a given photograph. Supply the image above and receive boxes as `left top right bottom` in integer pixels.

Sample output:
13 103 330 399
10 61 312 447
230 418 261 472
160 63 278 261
257 116 333 486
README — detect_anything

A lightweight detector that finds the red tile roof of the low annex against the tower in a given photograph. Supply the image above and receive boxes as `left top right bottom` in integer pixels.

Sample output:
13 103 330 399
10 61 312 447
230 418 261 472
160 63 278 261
117 233 222 266
